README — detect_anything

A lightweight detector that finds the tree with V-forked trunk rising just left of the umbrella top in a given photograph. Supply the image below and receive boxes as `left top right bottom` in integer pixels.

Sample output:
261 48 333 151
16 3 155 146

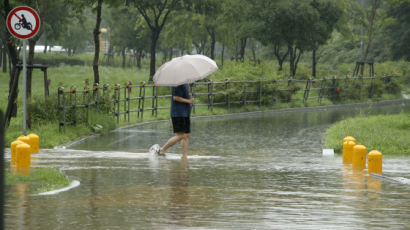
129 0 181 81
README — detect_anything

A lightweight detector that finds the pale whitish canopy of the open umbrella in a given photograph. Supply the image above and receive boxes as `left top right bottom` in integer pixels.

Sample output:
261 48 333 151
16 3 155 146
153 54 218 86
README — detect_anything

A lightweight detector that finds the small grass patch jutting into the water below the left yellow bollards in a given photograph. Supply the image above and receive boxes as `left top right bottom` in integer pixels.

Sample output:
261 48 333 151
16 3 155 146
5 168 70 194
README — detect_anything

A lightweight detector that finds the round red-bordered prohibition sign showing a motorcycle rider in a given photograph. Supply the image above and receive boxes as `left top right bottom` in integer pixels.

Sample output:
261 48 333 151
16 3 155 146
7 6 40 39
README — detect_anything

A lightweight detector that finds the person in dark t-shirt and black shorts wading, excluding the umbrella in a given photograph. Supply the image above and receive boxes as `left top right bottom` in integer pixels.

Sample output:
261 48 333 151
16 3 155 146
150 84 194 156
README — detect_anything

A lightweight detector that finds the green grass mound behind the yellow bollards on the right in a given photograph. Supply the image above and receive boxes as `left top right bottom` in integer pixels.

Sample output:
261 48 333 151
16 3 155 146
323 113 410 156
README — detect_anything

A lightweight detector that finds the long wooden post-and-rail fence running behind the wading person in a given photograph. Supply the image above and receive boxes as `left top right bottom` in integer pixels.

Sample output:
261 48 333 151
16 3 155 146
58 76 390 132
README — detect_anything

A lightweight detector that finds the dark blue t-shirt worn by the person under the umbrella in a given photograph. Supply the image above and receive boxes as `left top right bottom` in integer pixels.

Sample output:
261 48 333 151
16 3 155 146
171 84 191 117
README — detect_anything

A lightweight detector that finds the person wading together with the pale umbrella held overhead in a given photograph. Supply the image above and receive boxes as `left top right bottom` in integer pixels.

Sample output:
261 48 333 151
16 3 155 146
149 55 218 156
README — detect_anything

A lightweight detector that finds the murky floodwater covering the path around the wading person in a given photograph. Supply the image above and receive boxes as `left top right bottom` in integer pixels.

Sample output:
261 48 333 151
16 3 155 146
5 102 410 229
